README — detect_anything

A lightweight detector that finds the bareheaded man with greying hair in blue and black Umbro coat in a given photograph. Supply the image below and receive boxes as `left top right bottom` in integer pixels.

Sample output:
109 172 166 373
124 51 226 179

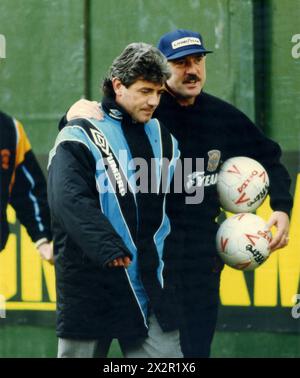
48 43 182 357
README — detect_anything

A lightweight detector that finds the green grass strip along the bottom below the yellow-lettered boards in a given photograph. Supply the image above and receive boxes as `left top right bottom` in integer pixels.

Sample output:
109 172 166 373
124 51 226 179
0 325 300 358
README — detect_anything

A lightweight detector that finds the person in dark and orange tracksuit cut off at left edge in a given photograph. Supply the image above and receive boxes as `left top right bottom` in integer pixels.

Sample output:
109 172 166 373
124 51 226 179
0 111 53 263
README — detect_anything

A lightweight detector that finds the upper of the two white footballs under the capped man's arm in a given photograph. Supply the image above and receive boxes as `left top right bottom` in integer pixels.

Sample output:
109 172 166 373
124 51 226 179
217 156 269 213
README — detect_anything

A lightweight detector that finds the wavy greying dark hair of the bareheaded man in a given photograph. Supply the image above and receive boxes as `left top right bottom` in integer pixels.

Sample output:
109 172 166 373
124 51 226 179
102 42 171 97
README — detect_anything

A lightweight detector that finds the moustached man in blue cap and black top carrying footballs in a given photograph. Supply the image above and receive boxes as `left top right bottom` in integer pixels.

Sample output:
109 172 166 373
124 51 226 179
59 29 292 357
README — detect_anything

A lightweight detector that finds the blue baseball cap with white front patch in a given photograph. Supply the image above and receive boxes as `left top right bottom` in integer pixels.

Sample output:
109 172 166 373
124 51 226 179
157 29 212 60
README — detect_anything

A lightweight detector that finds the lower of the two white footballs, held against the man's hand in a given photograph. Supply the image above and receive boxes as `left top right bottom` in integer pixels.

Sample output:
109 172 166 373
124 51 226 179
216 213 272 271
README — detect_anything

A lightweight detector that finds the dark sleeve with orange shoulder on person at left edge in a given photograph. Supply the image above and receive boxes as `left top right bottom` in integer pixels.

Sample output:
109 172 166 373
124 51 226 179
10 121 52 242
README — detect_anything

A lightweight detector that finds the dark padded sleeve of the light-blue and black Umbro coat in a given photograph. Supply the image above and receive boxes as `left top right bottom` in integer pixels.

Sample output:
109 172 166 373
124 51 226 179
48 142 132 267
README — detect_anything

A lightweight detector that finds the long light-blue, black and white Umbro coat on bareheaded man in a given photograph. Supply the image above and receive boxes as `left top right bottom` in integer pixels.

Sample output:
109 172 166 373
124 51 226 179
48 106 179 338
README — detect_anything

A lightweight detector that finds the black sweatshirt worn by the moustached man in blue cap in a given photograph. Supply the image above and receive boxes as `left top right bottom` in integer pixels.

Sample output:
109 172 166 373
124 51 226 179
155 92 292 280
